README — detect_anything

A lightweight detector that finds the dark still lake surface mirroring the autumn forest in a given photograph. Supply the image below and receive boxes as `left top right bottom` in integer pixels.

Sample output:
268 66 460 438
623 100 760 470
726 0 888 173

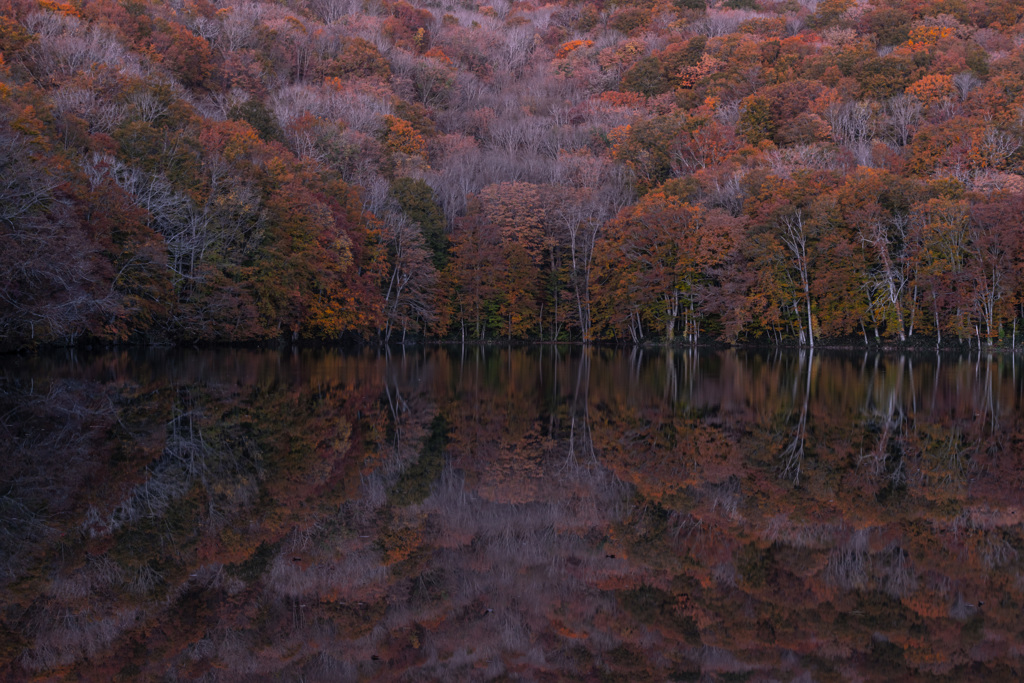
0 347 1024 681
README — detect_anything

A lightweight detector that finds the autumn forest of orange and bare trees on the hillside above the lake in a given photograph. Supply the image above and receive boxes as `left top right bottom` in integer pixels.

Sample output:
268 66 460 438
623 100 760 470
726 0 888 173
0 0 1024 350
